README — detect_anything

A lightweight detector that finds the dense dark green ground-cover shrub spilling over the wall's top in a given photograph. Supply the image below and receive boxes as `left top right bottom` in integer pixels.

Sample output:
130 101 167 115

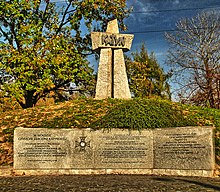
90 98 196 129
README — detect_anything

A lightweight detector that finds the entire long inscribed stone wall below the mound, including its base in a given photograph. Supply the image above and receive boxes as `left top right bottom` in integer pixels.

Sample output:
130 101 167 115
14 127 214 177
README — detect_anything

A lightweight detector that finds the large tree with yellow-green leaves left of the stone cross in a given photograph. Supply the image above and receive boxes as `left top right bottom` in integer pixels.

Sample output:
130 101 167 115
0 0 129 108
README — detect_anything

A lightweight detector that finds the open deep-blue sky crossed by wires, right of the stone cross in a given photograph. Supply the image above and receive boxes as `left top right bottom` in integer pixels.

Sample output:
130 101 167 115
125 0 220 70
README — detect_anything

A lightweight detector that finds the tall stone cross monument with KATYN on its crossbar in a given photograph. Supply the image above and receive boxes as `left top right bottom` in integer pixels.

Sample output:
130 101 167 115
91 19 134 99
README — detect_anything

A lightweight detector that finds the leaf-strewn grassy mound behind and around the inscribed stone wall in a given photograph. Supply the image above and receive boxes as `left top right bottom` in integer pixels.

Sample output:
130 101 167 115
0 98 220 165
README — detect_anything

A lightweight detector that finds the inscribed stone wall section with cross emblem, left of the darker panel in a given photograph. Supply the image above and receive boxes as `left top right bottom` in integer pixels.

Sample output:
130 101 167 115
14 128 153 169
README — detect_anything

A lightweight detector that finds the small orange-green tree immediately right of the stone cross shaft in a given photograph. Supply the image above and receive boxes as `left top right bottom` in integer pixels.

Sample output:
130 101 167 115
125 44 171 99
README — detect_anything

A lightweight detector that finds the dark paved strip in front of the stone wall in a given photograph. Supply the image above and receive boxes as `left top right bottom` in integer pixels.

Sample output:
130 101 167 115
0 175 220 192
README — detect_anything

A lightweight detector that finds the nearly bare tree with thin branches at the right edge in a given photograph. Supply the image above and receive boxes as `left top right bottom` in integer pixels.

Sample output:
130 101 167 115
166 11 220 108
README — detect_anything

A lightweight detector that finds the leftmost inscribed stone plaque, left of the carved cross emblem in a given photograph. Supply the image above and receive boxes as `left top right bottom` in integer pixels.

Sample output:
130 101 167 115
14 128 71 169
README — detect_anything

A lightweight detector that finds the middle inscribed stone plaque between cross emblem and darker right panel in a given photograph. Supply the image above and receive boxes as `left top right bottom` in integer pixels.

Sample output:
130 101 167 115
94 129 153 169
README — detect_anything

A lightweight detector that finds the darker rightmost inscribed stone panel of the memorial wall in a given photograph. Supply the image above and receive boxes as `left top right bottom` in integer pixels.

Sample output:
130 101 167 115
153 127 214 170
